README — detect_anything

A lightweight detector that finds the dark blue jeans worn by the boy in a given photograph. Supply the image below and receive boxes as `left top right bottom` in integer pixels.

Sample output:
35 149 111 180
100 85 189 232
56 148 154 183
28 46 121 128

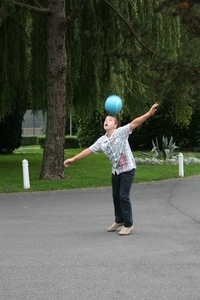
112 169 135 227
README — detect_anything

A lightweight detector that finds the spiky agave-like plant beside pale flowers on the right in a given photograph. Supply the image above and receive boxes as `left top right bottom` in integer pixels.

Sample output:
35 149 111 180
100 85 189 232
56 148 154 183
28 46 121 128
151 136 178 160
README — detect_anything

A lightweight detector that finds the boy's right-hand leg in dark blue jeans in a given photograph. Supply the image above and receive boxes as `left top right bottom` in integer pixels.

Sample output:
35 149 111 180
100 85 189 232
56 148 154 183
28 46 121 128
119 170 135 227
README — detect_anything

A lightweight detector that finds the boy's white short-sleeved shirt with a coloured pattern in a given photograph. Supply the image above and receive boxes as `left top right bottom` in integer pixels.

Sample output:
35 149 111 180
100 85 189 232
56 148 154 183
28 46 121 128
89 124 136 174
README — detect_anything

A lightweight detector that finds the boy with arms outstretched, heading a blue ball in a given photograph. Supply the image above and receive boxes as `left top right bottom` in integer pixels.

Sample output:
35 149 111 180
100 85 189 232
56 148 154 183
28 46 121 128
64 103 158 235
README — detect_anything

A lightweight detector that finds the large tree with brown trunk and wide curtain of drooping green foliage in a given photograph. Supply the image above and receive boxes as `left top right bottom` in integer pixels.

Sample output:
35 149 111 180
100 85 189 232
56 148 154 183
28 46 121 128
0 0 200 179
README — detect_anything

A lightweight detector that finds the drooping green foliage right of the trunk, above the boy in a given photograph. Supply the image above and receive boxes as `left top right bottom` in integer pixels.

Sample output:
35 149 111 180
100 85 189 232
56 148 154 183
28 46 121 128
67 0 200 127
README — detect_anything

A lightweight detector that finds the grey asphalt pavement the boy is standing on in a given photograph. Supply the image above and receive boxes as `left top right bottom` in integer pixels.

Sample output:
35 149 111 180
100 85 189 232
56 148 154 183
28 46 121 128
0 176 200 300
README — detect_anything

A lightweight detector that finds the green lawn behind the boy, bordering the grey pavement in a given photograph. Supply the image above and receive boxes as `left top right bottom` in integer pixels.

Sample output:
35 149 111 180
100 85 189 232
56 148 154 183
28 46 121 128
0 146 200 193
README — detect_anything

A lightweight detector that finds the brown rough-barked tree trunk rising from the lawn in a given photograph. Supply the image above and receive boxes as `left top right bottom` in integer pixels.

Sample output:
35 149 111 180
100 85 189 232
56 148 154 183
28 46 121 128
40 0 67 180
